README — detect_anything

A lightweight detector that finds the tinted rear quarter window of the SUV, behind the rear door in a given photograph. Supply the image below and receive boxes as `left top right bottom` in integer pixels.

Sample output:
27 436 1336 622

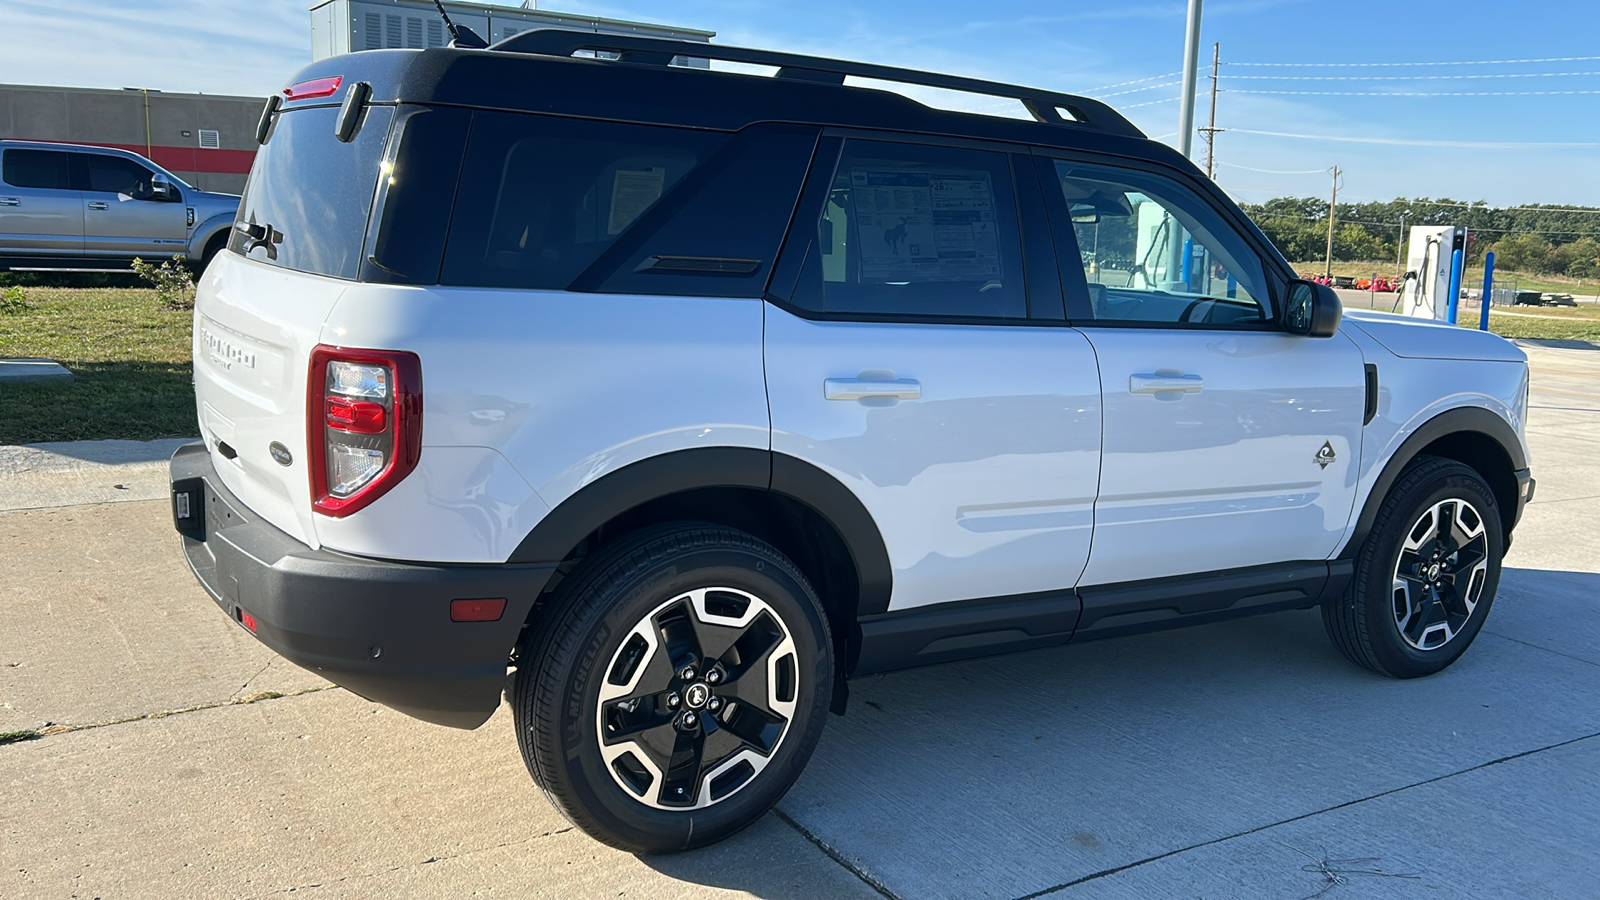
440 112 726 290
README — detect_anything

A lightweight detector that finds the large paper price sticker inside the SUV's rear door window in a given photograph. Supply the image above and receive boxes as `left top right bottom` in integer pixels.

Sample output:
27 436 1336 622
850 167 1000 282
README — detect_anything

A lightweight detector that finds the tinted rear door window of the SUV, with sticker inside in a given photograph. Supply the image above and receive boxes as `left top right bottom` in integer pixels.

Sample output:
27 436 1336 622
795 141 1027 319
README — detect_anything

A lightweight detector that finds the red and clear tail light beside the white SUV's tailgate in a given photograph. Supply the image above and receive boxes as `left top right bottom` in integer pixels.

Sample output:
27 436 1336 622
306 344 422 517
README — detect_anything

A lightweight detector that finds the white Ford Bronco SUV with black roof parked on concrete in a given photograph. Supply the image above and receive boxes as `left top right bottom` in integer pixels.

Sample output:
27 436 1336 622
171 32 1533 850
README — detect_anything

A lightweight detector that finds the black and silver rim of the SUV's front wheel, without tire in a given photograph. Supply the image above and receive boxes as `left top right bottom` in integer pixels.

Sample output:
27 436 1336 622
1392 498 1488 650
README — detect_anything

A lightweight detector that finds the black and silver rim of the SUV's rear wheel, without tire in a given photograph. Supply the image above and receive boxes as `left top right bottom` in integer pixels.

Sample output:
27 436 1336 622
597 588 798 809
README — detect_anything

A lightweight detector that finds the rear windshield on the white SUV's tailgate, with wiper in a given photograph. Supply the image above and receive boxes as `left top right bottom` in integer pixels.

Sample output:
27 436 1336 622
229 106 394 280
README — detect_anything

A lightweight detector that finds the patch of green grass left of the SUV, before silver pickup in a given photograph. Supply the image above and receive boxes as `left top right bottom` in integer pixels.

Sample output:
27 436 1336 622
0 287 198 444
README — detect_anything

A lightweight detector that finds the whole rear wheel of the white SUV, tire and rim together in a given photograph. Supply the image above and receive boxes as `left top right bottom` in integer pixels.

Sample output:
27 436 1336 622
510 524 834 854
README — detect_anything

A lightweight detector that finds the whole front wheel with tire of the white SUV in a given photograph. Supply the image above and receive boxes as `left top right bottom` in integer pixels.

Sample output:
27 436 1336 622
1322 456 1506 677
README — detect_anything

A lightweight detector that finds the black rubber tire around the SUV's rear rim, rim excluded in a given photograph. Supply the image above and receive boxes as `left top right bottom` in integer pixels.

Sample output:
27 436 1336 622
510 524 834 852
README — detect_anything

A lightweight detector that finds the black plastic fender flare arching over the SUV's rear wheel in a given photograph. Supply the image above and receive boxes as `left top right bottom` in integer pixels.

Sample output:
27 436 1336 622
506 447 893 615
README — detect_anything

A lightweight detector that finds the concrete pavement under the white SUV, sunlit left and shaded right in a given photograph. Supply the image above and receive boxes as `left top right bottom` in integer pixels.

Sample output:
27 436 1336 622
0 339 1600 898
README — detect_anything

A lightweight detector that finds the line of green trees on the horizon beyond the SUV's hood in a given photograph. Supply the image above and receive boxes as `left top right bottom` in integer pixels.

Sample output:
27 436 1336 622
1243 197 1600 279
